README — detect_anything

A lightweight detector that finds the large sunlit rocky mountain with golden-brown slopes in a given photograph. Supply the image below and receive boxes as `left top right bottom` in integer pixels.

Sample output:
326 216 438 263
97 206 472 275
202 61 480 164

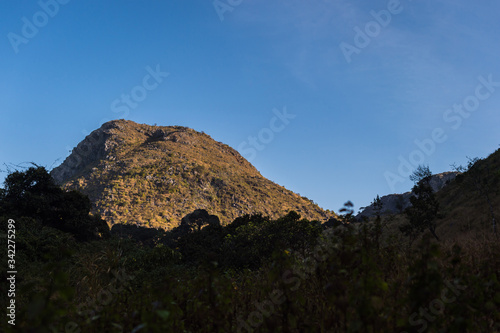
51 120 329 229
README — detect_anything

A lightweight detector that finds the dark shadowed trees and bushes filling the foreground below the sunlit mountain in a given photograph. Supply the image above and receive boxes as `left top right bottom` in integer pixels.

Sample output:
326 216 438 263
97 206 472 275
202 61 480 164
0 168 500 332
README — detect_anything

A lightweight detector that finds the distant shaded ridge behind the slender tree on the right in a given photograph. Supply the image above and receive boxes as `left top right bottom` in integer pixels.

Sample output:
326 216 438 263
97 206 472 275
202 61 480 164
356 171 458 219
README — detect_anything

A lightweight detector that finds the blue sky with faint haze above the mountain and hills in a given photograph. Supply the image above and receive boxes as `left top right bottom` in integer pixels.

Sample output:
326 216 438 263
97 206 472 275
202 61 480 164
0 0 500 211
